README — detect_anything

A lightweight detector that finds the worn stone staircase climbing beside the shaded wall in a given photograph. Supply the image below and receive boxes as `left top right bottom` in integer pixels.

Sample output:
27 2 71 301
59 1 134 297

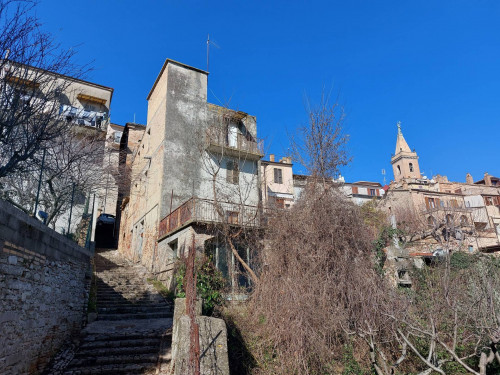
52 250 173 375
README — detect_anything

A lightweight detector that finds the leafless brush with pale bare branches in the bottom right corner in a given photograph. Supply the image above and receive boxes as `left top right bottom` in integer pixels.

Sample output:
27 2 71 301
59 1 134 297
396 253 500 375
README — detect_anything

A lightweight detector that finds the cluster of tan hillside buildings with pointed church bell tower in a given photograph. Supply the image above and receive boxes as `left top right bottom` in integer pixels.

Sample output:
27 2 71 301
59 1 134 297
380 123 500 253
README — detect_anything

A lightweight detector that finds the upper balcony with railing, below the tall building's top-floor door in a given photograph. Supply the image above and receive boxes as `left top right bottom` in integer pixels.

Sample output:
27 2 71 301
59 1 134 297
206 128 264 160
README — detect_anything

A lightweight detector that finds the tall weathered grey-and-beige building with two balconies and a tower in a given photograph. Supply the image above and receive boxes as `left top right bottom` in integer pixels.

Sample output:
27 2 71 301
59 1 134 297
119 59 262 290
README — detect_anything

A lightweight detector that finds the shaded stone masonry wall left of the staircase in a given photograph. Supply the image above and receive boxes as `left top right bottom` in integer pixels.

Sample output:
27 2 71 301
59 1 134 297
0 200 92 375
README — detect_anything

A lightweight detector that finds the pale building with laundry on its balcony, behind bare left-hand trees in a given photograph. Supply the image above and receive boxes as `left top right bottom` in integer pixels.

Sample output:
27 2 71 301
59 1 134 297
0 60 116 239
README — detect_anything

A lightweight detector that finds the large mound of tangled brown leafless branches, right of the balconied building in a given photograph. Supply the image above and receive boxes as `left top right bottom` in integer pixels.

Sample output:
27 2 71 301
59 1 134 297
232 184 406 374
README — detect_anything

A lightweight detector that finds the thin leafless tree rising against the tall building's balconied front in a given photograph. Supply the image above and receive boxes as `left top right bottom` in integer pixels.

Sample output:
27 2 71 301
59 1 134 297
198 106 261 290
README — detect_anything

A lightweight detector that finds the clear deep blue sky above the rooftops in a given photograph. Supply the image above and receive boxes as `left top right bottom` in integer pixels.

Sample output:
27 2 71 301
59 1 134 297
37 0 500 182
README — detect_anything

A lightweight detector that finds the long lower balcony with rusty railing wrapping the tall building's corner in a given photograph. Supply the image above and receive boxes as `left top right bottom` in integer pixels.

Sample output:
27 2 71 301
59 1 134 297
158 198 260 241
